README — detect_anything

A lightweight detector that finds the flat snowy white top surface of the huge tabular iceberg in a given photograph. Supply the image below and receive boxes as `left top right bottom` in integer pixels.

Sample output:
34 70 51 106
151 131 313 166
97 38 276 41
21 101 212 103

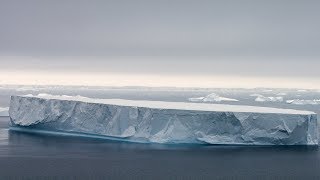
22 94 315 115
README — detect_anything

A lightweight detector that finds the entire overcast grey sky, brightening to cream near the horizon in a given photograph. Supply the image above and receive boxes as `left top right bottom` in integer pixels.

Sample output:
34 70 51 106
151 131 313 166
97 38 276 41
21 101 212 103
0 0 320 89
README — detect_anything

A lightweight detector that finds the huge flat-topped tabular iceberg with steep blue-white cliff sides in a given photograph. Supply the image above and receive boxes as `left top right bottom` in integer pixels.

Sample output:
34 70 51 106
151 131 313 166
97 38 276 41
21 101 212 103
9 95 318 145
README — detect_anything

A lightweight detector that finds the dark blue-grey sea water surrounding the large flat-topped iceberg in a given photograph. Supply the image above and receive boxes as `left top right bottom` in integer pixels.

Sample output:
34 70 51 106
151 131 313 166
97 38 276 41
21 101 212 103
0 86 320 180
